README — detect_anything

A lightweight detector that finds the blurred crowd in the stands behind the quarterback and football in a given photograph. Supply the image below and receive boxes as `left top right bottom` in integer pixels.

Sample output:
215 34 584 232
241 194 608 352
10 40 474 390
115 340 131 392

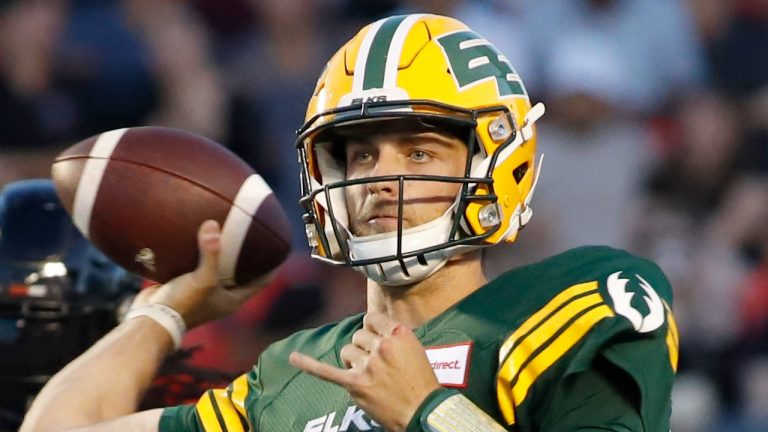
0 0 768 432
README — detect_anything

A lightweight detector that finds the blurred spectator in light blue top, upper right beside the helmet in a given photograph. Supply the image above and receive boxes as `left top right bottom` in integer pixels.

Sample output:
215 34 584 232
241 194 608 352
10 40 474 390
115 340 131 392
525 0 706 115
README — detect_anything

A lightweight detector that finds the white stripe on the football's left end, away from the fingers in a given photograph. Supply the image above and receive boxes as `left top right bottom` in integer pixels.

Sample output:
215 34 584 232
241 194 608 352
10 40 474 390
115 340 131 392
72 128 128 237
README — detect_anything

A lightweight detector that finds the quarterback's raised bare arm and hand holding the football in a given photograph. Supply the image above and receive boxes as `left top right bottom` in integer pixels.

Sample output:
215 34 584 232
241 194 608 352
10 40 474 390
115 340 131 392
21 222 265 432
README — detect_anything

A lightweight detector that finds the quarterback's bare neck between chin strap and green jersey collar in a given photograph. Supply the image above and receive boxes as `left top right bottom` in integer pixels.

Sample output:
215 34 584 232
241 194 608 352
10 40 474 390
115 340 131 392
368 252 488 328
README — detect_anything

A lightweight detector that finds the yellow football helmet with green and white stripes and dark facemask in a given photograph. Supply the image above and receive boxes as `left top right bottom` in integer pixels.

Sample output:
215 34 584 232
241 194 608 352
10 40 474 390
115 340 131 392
297 14 544 285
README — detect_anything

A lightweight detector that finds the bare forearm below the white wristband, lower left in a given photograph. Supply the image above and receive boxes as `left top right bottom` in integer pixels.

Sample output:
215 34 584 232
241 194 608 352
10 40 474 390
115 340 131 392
21 317 173 431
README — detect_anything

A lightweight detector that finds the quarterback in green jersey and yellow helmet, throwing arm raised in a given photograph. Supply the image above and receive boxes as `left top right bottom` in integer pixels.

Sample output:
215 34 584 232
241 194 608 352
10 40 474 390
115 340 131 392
22 15 678 432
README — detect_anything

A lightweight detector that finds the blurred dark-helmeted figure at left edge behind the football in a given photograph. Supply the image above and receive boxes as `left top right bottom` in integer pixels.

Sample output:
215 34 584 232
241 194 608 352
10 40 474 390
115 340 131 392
0 179 141 430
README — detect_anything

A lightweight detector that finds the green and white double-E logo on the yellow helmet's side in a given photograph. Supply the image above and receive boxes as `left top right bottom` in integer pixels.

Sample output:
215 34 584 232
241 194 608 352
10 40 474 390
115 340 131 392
436 30 526 97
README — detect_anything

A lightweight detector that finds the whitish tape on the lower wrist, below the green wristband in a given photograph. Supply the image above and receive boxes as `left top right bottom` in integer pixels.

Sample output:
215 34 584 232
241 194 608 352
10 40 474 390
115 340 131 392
427 394 506 432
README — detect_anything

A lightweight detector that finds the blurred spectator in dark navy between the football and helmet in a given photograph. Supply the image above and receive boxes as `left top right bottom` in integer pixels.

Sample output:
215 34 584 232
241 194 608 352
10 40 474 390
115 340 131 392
213 0 340 250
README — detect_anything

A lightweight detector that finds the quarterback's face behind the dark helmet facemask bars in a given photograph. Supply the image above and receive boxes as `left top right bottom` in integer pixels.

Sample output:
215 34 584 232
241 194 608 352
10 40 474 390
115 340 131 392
345 132 467 236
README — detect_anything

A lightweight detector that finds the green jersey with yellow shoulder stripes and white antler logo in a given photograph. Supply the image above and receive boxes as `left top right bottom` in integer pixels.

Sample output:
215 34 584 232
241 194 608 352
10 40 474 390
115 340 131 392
160 247 678 432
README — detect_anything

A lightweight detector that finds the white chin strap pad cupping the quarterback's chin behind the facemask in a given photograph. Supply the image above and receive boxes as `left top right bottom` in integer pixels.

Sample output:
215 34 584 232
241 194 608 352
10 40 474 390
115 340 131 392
347 206 455 286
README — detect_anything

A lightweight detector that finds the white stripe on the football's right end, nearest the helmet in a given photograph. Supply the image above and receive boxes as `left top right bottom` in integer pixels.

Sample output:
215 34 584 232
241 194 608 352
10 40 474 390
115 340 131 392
219 174 272 285
